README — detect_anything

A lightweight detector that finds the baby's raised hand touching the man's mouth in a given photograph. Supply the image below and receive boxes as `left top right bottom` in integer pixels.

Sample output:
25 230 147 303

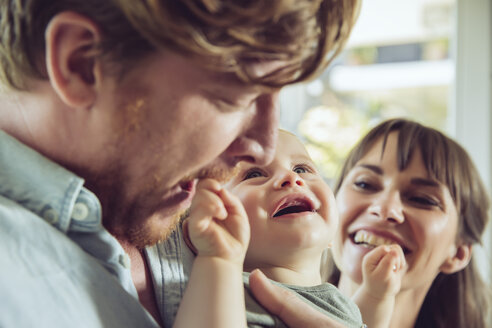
184 179 250 266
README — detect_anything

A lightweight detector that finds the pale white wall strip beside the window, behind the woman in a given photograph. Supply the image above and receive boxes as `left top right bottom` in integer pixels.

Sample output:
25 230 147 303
449 0 492 281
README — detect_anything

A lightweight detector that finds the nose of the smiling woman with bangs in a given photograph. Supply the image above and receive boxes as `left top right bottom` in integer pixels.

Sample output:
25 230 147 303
369 191 405 223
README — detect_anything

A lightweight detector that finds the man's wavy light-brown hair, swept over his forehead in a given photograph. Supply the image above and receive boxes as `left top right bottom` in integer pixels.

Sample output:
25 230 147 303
0 0 360 90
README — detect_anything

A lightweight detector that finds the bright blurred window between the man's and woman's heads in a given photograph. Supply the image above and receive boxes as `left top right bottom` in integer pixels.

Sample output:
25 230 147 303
281 0 455 181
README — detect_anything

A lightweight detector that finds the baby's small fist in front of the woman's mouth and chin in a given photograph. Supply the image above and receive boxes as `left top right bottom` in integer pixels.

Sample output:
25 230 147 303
362 244 407 299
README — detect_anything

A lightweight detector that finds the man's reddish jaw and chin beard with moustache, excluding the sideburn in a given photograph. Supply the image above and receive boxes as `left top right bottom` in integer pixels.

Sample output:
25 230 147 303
82 166 237 249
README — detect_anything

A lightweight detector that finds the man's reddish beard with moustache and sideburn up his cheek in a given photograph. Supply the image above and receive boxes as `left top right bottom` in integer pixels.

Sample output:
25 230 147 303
65 92 241 249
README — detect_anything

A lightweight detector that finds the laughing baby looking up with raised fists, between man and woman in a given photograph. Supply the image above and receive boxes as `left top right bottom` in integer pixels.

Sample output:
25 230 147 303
175 130 405 328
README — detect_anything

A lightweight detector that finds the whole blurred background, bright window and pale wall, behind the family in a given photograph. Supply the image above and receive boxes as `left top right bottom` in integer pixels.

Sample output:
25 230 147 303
280 0 492 281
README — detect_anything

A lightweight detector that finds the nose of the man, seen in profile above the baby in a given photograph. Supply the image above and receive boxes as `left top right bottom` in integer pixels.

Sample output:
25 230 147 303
228 91 280 166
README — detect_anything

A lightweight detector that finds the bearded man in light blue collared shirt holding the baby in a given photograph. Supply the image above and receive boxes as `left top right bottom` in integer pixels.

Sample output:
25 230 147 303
0 0 357 327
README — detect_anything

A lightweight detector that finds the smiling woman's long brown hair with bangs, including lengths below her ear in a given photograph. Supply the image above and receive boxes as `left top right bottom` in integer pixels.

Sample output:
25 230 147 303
329 119 491 328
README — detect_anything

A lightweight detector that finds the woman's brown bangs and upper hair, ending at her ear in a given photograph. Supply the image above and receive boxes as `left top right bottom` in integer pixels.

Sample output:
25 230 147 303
334 119 489 243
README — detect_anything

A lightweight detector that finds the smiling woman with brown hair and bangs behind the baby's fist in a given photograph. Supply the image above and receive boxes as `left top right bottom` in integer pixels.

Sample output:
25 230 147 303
330 119 490 328
